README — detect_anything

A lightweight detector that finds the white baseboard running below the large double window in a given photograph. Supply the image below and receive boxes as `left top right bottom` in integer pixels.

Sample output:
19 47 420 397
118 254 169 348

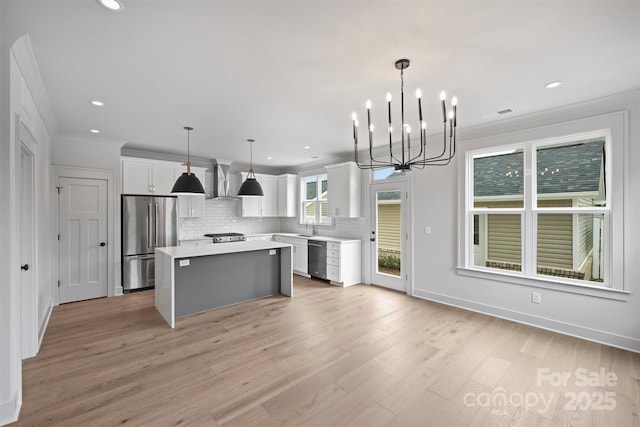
414 289 640 353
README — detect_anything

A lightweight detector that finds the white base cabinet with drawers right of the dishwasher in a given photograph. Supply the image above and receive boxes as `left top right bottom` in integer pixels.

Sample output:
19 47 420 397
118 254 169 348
327 240 362 286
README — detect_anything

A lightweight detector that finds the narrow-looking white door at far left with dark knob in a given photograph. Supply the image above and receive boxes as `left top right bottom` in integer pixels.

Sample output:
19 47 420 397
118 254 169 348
18 127 38 359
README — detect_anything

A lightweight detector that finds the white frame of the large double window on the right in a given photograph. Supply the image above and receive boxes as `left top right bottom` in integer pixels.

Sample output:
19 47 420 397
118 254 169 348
457 111 630 300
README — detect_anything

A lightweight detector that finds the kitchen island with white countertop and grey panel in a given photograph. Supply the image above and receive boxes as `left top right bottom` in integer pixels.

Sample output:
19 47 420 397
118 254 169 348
155 241 293 328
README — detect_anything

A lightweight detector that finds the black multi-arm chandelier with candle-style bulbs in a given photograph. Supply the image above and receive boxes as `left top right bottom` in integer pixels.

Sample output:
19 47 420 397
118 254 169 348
351 59 458 171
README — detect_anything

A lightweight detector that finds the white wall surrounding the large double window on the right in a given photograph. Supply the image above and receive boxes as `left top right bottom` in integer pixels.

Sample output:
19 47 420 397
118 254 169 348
411 91 640 351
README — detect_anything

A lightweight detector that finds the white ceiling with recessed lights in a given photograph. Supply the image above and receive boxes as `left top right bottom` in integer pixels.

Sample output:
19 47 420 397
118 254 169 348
0 0 640 166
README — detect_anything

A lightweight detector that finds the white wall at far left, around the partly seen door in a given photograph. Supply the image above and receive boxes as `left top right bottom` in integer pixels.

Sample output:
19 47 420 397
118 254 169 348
0 32 57 424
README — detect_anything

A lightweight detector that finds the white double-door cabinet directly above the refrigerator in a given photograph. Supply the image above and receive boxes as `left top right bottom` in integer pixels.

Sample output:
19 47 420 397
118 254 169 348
122 157 179 195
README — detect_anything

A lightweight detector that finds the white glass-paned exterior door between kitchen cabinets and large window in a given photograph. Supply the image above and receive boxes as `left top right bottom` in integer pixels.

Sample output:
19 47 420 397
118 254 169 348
370 181 408 292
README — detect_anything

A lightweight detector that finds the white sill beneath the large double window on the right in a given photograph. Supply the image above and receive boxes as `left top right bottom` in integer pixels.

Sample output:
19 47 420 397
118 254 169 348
456 267 630 301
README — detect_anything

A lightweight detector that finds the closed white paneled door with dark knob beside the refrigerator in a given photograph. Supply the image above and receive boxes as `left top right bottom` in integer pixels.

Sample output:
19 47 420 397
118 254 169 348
58 177 108 304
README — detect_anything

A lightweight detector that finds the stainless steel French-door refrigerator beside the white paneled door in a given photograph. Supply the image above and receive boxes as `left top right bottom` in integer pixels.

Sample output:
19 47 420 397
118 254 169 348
121 195 178 292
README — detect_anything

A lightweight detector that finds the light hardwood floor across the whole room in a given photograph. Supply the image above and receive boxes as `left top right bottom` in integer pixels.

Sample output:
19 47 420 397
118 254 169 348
13 276 640 426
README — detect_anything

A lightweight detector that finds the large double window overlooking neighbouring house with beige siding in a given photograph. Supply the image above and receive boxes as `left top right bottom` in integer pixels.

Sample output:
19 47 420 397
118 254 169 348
461 115 624 296
